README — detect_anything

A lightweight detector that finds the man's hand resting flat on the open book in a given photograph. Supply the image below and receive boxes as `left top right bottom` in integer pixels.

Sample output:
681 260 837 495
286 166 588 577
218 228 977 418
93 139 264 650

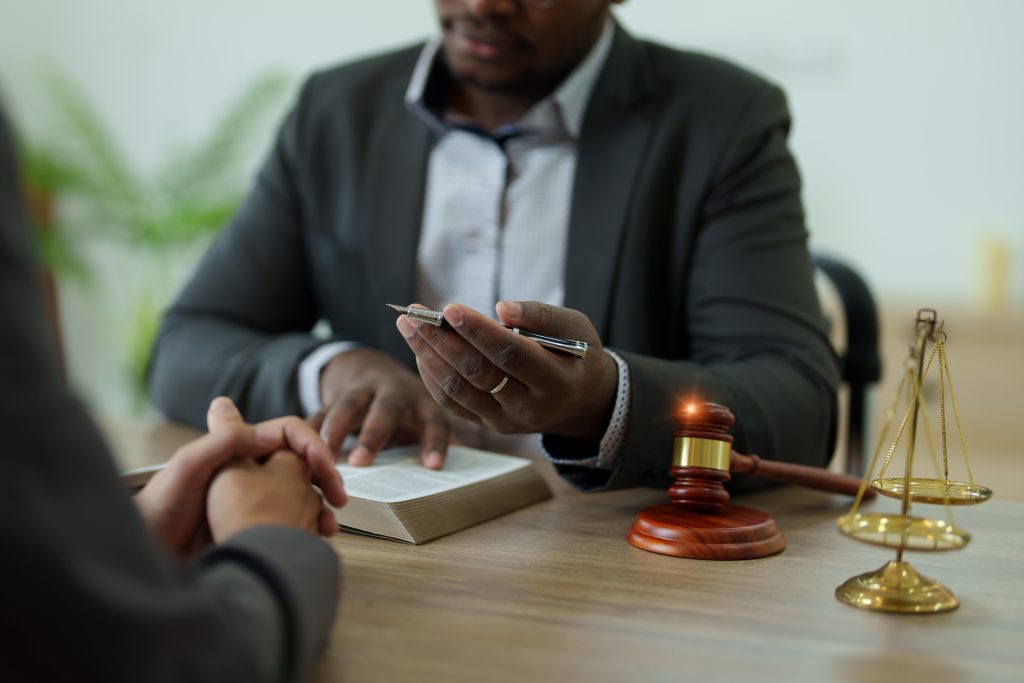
311 348 451 469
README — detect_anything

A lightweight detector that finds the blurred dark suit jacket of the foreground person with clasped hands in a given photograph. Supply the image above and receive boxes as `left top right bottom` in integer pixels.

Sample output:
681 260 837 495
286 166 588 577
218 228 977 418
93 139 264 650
0 104 339 681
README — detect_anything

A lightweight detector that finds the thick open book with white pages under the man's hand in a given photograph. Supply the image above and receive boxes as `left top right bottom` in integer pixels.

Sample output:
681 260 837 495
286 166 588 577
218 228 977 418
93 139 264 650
334 445 551 543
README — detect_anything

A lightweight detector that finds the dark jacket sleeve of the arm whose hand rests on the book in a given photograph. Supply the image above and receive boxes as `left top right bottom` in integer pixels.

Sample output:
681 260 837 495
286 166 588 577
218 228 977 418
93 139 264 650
148 81 323 426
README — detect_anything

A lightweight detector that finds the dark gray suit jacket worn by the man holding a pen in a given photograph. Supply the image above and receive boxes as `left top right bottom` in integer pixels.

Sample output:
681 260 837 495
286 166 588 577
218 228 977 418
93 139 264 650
151 28 838 488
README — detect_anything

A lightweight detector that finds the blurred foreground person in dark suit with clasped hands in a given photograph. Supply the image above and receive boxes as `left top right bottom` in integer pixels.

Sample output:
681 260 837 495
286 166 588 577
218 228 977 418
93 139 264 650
0 100 345 681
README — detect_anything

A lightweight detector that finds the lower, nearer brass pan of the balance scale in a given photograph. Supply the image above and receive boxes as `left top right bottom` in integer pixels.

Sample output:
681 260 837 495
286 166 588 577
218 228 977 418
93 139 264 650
836 512 971 550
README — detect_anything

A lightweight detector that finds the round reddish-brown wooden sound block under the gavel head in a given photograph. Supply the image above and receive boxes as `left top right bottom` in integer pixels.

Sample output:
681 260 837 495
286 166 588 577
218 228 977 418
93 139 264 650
627 503 785 560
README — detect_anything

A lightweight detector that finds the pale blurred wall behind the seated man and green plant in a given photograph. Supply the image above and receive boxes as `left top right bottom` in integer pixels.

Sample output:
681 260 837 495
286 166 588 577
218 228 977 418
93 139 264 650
0 0 1024 428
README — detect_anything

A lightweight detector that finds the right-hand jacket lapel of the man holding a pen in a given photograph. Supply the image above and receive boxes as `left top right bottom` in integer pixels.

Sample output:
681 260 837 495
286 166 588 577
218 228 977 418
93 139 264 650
565 27 652 337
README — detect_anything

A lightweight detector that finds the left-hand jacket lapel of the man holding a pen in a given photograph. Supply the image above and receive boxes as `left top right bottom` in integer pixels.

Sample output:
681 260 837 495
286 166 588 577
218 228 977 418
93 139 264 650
364 92 433 354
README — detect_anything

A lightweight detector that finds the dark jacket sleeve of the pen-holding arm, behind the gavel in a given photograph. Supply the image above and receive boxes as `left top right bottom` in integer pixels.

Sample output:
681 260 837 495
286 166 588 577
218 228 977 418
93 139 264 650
559 83 839 489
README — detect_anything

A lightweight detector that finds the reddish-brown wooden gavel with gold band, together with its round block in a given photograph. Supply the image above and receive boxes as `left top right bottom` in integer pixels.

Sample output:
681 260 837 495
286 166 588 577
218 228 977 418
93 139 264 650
627 402 860 560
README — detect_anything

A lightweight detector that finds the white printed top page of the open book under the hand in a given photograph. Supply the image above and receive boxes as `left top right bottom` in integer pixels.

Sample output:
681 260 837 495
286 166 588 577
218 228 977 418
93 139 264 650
337 444 530 503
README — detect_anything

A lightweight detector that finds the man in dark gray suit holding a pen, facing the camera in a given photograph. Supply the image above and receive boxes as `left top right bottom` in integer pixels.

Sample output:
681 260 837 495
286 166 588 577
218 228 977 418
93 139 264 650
151 0 838 489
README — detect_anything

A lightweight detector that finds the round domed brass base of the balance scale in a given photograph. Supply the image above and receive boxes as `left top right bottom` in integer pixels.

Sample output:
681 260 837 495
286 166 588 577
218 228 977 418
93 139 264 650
836 560 959 614
